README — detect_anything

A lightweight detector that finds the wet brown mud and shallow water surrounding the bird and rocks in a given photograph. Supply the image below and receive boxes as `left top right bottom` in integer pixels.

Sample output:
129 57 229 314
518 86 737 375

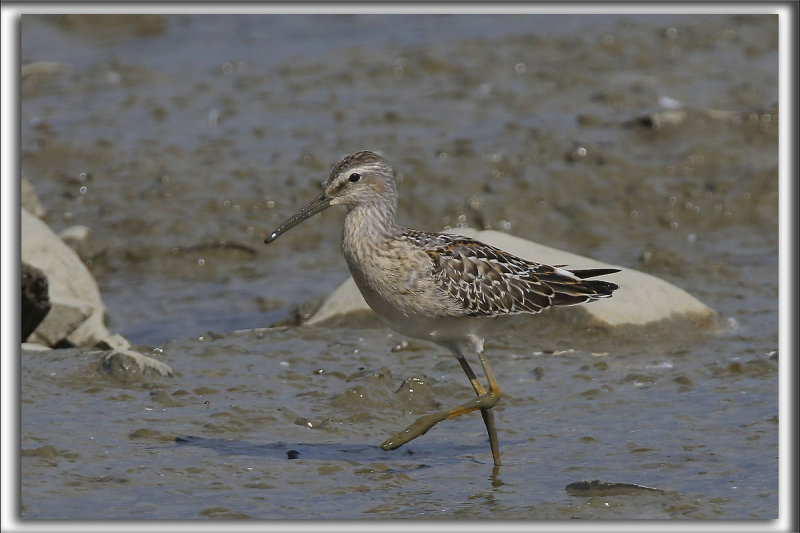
20 15 778 519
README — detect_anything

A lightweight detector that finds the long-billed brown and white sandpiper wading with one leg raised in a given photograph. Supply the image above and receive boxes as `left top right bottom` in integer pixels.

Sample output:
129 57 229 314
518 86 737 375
264 151 618 465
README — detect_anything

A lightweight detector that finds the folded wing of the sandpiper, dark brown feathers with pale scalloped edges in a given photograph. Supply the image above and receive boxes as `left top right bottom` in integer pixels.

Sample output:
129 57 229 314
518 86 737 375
406 231 618 316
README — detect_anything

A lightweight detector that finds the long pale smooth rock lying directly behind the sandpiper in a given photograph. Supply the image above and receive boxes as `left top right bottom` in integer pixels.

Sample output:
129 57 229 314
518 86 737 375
306 228 717 326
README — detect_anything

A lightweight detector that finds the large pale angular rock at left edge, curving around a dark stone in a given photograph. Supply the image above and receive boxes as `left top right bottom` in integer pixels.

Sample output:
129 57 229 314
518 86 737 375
21 209 110 346
